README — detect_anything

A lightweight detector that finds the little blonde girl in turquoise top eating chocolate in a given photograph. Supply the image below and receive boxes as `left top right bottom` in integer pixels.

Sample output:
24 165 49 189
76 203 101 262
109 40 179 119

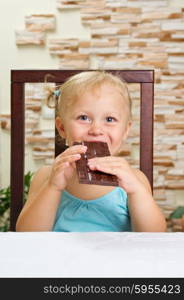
16 71 166 232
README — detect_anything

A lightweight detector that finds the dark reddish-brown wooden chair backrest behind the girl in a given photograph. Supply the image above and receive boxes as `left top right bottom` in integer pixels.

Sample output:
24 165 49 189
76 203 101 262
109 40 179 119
10 70 154 231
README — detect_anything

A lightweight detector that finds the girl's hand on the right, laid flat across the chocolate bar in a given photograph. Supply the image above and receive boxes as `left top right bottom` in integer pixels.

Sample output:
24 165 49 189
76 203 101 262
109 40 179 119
88 156 144 194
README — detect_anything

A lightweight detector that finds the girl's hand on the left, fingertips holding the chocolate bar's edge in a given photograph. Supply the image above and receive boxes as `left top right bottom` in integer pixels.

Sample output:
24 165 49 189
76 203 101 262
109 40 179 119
48 145 87 191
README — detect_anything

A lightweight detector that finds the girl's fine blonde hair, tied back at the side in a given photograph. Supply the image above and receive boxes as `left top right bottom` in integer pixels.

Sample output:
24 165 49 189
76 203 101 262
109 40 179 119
47 71 131 119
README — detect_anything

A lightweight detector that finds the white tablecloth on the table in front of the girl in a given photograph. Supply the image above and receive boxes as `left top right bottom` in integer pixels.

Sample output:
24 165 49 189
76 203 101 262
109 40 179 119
0 232 184 278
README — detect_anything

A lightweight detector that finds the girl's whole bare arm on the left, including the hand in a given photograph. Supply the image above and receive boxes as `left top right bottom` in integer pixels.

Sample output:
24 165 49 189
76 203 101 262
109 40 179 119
16 145 87 231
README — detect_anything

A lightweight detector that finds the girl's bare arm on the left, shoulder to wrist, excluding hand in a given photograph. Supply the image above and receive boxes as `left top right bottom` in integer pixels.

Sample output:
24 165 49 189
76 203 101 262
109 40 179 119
16 167 61 231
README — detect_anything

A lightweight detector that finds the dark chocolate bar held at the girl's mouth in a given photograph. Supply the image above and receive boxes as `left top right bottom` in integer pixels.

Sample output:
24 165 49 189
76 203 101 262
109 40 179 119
74 142 118 186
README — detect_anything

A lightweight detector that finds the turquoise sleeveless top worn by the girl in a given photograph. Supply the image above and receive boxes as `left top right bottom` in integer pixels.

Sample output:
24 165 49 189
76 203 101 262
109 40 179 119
52 187 131 232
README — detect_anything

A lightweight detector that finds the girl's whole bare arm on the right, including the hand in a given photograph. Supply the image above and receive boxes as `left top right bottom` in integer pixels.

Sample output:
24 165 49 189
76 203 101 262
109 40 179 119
88 156 166 232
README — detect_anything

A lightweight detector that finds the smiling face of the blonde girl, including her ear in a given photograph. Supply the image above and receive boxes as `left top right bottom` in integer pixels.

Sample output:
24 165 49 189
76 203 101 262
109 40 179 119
56 84 130 155
